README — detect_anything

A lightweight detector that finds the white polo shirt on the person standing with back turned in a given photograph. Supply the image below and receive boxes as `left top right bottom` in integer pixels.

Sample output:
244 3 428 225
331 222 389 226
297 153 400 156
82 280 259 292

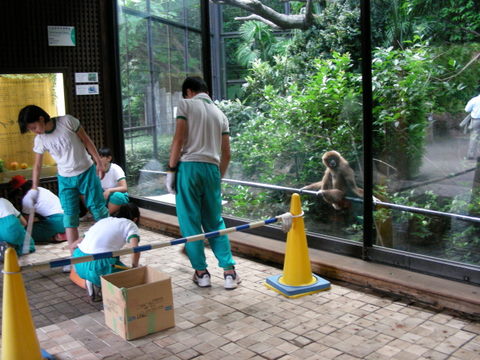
177 93 229 165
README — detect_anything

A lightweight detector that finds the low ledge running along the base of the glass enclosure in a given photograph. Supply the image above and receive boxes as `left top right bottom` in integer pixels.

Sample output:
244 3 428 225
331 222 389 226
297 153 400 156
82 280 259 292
141 209 480 318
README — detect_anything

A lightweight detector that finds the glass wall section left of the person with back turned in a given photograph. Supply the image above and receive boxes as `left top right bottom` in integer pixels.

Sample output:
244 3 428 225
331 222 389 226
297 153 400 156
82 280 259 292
118 0 203 199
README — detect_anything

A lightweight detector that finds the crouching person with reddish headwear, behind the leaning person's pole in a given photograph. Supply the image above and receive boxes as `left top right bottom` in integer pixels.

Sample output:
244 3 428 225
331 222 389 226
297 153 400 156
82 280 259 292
9 175 66 243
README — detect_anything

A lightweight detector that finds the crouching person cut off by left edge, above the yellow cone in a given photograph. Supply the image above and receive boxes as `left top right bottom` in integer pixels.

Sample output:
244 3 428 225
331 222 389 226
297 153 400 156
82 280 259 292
0 197 35 262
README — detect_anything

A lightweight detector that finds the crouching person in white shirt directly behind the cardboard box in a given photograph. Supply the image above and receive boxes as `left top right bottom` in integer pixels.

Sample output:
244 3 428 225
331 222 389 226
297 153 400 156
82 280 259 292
73 203 140 301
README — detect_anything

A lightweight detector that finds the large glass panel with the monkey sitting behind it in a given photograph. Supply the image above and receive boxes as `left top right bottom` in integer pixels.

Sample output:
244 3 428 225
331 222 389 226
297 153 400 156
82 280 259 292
220 2 363 242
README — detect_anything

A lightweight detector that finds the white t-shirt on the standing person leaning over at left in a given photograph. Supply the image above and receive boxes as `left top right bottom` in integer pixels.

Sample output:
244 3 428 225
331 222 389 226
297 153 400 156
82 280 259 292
33 115 93 177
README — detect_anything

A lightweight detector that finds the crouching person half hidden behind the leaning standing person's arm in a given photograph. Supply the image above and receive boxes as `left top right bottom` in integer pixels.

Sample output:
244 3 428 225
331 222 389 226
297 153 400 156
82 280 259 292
98 148 129 214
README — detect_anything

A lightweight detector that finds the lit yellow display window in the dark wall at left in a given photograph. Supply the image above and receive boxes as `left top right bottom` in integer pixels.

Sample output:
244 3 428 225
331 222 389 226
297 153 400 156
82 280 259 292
0 73 65 183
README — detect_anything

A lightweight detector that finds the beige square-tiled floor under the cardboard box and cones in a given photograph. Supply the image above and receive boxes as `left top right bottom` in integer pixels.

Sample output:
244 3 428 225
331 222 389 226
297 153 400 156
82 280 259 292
0 224 480 360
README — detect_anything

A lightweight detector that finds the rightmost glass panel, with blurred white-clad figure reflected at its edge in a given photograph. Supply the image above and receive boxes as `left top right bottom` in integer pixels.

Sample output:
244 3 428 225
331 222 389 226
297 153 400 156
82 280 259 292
372 1 480 265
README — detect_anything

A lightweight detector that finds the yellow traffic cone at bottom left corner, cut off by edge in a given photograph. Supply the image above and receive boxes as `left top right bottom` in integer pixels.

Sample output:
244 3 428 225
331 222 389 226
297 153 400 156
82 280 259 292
2 248 54 360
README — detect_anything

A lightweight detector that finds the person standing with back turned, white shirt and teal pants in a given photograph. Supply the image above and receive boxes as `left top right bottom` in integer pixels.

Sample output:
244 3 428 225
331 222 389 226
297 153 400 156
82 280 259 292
165 77 240 290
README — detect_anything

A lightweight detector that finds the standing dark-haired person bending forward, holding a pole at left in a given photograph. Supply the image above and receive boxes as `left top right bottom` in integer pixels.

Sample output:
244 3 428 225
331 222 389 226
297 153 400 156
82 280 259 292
18 105 108 258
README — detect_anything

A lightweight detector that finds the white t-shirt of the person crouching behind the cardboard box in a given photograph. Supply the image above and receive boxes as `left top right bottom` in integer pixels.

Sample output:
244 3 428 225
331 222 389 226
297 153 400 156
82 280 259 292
78 217 140 254
